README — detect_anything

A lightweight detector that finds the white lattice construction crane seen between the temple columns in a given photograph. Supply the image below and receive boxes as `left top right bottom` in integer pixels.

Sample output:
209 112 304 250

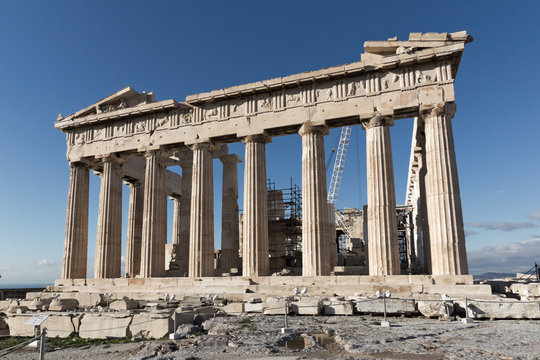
327 126 352 240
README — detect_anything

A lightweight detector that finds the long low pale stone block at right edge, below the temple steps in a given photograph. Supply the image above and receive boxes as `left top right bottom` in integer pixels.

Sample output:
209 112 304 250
455 300 540 319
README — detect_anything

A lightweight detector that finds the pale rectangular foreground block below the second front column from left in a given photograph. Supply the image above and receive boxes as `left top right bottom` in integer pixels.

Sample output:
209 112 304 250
79 313 133 339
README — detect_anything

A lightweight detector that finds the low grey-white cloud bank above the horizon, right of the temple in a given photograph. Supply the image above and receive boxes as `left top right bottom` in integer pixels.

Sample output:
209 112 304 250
467 236 540 274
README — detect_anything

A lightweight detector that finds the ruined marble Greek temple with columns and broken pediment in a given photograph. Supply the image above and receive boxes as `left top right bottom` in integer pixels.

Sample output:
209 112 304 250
55 31 472 279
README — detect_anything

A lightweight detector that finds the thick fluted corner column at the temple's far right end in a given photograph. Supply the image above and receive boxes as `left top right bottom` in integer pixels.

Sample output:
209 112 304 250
421 103 468 275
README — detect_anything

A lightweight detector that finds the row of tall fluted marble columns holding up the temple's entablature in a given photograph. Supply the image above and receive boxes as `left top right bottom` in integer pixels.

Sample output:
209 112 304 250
62 104 467 278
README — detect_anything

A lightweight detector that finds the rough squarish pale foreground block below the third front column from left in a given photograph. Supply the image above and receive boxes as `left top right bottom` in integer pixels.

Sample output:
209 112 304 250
129 311 174 339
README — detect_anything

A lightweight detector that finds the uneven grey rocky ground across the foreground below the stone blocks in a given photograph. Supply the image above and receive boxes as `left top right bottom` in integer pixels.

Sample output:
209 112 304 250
6 315 540 360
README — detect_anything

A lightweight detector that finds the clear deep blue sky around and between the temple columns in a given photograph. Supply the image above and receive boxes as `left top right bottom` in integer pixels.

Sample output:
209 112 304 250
0 0 540 288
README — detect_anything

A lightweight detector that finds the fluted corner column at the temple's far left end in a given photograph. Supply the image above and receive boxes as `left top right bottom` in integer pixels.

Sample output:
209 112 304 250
62 163 89 279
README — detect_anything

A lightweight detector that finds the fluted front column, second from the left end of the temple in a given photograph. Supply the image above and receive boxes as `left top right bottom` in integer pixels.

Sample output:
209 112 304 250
94 155 122 279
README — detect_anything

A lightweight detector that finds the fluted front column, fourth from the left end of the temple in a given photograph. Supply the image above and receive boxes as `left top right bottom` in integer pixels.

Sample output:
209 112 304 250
189 143 214 277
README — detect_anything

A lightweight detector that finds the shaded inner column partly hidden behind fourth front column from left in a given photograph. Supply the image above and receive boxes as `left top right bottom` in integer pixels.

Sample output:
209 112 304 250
176 158 193 276
